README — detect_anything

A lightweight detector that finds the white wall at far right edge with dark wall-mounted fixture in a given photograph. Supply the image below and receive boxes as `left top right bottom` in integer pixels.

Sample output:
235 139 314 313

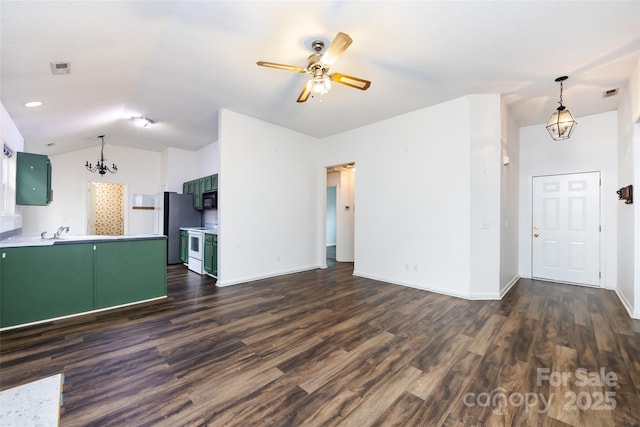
616 59 640 319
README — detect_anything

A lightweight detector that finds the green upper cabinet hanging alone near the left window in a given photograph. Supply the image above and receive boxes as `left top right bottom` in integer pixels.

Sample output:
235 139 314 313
16 152 51 206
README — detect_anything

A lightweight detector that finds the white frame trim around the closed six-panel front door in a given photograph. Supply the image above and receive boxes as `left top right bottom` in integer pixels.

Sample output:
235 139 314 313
528 170 607 288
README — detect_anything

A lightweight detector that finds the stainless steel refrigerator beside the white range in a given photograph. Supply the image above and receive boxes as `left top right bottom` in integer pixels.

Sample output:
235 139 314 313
156 191 202 264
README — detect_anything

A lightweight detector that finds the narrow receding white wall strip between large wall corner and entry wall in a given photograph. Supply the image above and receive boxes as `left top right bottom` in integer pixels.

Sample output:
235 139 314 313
500 101 520 295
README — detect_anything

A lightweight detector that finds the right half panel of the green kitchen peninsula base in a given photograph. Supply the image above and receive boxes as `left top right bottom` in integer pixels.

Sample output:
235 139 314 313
94 239 167 309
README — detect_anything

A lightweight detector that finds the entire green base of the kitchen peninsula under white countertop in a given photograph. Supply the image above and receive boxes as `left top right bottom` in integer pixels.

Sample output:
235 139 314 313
0 238 167 328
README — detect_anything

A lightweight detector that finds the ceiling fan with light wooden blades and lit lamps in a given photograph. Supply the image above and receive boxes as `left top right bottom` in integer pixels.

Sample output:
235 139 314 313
257 33 371 102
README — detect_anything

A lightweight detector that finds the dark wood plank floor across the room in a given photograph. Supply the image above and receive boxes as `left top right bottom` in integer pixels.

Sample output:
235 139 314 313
0 263 640 427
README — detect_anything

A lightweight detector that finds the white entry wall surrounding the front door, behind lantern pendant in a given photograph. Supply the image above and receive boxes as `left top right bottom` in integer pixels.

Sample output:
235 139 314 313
519 111 618 289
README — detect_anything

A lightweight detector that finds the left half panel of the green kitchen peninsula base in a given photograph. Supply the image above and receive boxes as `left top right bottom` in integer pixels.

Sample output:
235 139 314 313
0 243 94 328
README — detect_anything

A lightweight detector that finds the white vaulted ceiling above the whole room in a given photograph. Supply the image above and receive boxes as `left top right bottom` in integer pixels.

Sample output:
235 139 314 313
0 0 640 154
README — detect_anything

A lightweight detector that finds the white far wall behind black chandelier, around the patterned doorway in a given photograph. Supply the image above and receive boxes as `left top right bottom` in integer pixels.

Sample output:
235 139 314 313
22 143 161 234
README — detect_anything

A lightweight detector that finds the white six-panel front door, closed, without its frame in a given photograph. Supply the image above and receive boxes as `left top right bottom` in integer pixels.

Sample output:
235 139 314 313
531 172 600 286
